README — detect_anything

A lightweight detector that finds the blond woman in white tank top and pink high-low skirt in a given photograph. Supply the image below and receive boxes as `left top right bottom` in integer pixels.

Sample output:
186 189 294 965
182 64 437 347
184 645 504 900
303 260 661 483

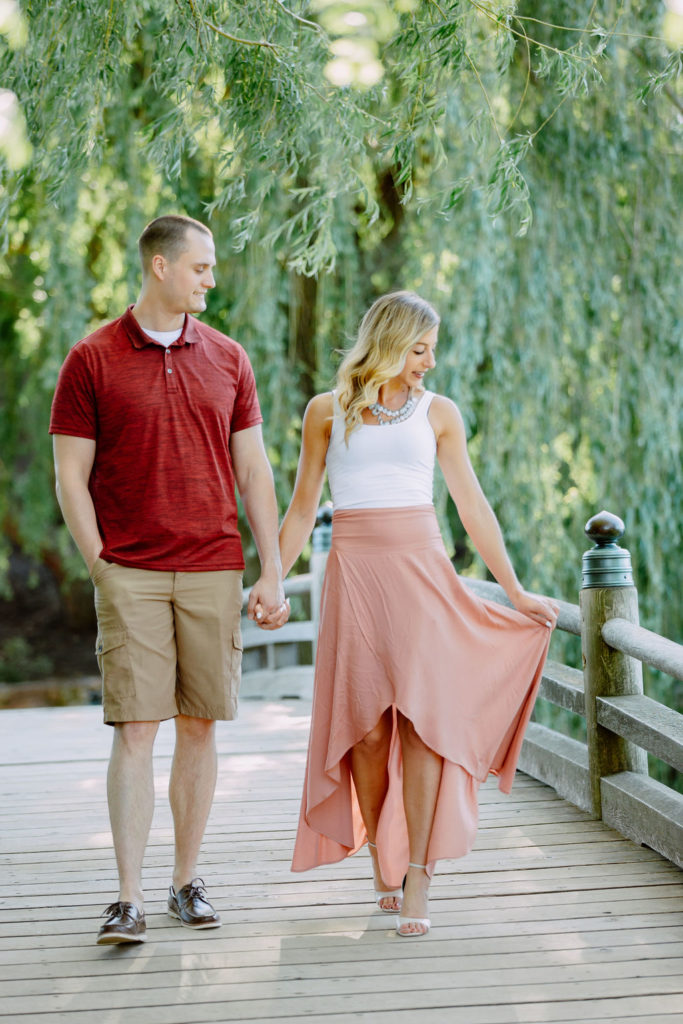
274 292 558 936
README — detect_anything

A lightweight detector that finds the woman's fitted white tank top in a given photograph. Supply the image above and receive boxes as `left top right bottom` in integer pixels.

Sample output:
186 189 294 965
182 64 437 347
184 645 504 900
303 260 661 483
326 391 436 510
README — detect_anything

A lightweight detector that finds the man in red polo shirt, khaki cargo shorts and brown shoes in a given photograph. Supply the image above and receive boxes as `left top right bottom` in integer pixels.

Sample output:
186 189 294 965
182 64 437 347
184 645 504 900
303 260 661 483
50 216 288 943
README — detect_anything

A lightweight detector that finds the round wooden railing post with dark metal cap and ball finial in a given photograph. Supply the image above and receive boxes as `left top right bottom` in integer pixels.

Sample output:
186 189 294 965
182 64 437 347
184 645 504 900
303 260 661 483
579 512 647 818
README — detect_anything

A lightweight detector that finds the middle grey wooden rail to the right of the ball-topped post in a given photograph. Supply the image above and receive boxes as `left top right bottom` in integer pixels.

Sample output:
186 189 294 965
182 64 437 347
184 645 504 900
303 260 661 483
597 693 683 771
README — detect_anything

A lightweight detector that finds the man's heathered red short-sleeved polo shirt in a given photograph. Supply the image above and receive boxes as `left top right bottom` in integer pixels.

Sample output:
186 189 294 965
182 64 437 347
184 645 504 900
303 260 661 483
50 309 262 571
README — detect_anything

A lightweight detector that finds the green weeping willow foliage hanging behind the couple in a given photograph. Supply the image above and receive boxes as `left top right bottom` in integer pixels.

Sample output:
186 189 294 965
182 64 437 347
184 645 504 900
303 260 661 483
0 0 683 675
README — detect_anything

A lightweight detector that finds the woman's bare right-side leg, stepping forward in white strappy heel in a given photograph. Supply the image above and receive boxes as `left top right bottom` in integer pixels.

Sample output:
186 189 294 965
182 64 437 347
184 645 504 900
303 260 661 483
398 712 443 934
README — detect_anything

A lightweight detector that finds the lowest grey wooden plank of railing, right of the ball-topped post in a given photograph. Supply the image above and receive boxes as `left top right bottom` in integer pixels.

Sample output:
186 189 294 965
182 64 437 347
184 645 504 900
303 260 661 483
601 772 683 867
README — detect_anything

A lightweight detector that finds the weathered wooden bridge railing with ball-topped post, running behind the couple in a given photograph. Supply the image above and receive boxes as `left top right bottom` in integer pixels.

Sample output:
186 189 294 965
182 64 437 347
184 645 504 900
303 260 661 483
243 513 683 866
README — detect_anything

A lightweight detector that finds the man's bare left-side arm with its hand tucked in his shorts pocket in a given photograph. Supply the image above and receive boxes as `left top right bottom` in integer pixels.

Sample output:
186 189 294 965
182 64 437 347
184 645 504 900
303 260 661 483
53 434 102 572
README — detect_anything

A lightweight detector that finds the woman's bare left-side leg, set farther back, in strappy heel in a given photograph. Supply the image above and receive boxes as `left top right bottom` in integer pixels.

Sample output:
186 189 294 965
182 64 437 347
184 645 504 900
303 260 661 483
350 708 400 910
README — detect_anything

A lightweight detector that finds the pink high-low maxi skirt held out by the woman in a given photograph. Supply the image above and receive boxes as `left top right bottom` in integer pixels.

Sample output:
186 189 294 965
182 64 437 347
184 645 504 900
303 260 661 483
292 506 550 887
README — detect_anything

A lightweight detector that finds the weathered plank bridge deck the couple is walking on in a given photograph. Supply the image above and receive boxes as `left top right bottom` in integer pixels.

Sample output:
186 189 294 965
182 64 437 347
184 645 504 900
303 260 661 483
0 700 683 1024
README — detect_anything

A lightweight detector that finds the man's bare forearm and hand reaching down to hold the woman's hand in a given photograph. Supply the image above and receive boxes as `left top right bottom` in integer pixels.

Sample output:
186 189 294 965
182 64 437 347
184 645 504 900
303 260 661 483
230 426 289 629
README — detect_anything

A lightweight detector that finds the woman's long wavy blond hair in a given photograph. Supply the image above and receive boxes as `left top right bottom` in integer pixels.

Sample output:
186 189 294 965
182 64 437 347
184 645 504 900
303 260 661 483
337 292 439 441
